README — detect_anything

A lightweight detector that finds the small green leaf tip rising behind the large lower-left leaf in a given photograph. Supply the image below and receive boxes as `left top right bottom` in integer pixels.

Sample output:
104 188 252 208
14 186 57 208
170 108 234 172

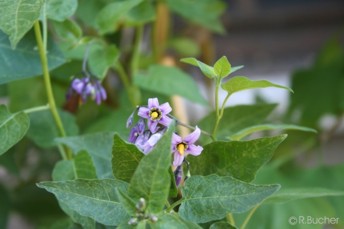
73 151 97 179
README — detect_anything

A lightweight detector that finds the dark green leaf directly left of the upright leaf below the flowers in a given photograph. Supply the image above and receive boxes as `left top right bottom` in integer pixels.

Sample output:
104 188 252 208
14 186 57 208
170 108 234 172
112 134 144 182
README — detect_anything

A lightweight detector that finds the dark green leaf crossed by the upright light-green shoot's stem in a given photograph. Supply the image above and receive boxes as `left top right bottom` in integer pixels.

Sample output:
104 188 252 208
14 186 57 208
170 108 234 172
199 104 276 142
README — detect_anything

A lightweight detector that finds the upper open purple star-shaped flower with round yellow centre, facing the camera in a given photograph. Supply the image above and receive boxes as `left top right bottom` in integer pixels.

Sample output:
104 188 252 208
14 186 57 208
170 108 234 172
138 98 172 133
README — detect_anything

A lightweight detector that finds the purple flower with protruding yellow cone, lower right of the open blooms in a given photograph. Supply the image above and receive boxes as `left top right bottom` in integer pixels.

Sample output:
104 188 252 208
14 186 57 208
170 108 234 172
172 126 203 167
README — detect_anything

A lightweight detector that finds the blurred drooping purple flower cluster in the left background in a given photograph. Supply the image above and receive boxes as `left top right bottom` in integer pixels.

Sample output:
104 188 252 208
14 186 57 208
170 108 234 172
67 76 106 105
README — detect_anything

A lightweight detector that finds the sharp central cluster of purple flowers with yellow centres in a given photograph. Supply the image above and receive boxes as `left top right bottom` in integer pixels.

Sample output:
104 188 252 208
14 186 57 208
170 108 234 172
127 98 203 167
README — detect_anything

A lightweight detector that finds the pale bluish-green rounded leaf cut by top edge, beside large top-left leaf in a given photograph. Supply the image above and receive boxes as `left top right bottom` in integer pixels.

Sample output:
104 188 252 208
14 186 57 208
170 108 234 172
43 0 78 22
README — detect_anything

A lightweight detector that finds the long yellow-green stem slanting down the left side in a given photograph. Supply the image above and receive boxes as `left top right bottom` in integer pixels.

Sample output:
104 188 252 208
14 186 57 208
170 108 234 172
34 21 71 158
